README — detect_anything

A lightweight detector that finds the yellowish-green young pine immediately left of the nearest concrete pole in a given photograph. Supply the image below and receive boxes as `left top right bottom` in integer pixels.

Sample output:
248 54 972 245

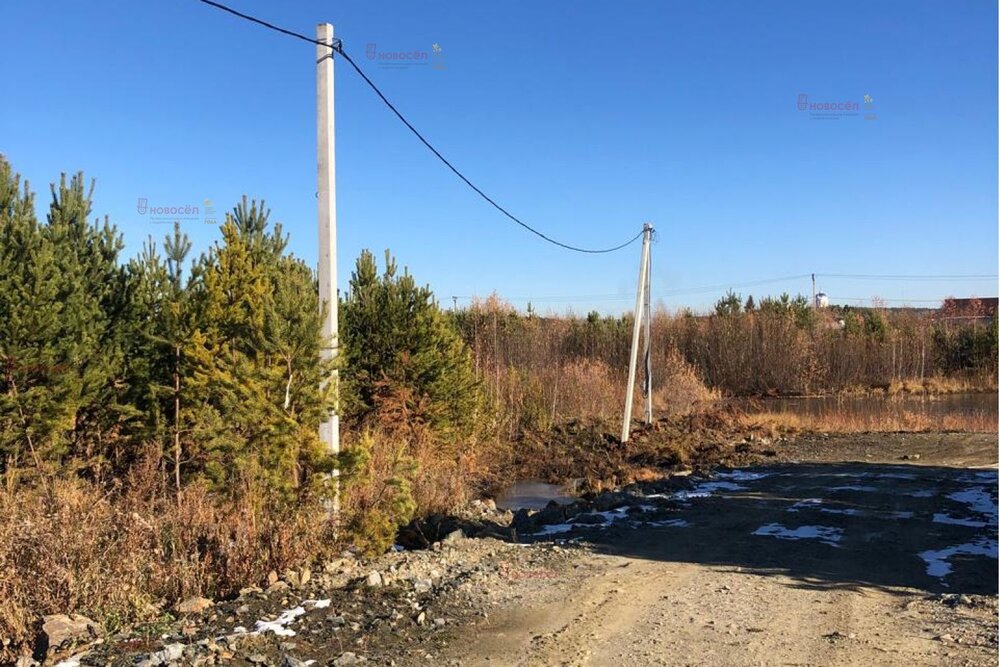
181 198 333 497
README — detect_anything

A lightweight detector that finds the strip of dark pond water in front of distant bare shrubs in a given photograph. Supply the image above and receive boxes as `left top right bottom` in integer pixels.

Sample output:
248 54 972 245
742 393 998 420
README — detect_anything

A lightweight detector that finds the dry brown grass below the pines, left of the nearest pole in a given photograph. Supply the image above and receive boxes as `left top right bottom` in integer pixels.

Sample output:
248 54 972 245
0 454 329 662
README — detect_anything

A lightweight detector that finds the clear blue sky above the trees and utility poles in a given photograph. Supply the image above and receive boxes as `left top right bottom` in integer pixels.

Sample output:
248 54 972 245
0 0 998 312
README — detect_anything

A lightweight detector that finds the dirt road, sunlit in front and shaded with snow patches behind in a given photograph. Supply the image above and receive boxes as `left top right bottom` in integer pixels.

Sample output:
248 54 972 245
437 435 997 667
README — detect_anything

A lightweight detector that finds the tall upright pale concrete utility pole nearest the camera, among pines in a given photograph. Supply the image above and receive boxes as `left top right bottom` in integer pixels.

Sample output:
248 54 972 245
316 23 340 514
